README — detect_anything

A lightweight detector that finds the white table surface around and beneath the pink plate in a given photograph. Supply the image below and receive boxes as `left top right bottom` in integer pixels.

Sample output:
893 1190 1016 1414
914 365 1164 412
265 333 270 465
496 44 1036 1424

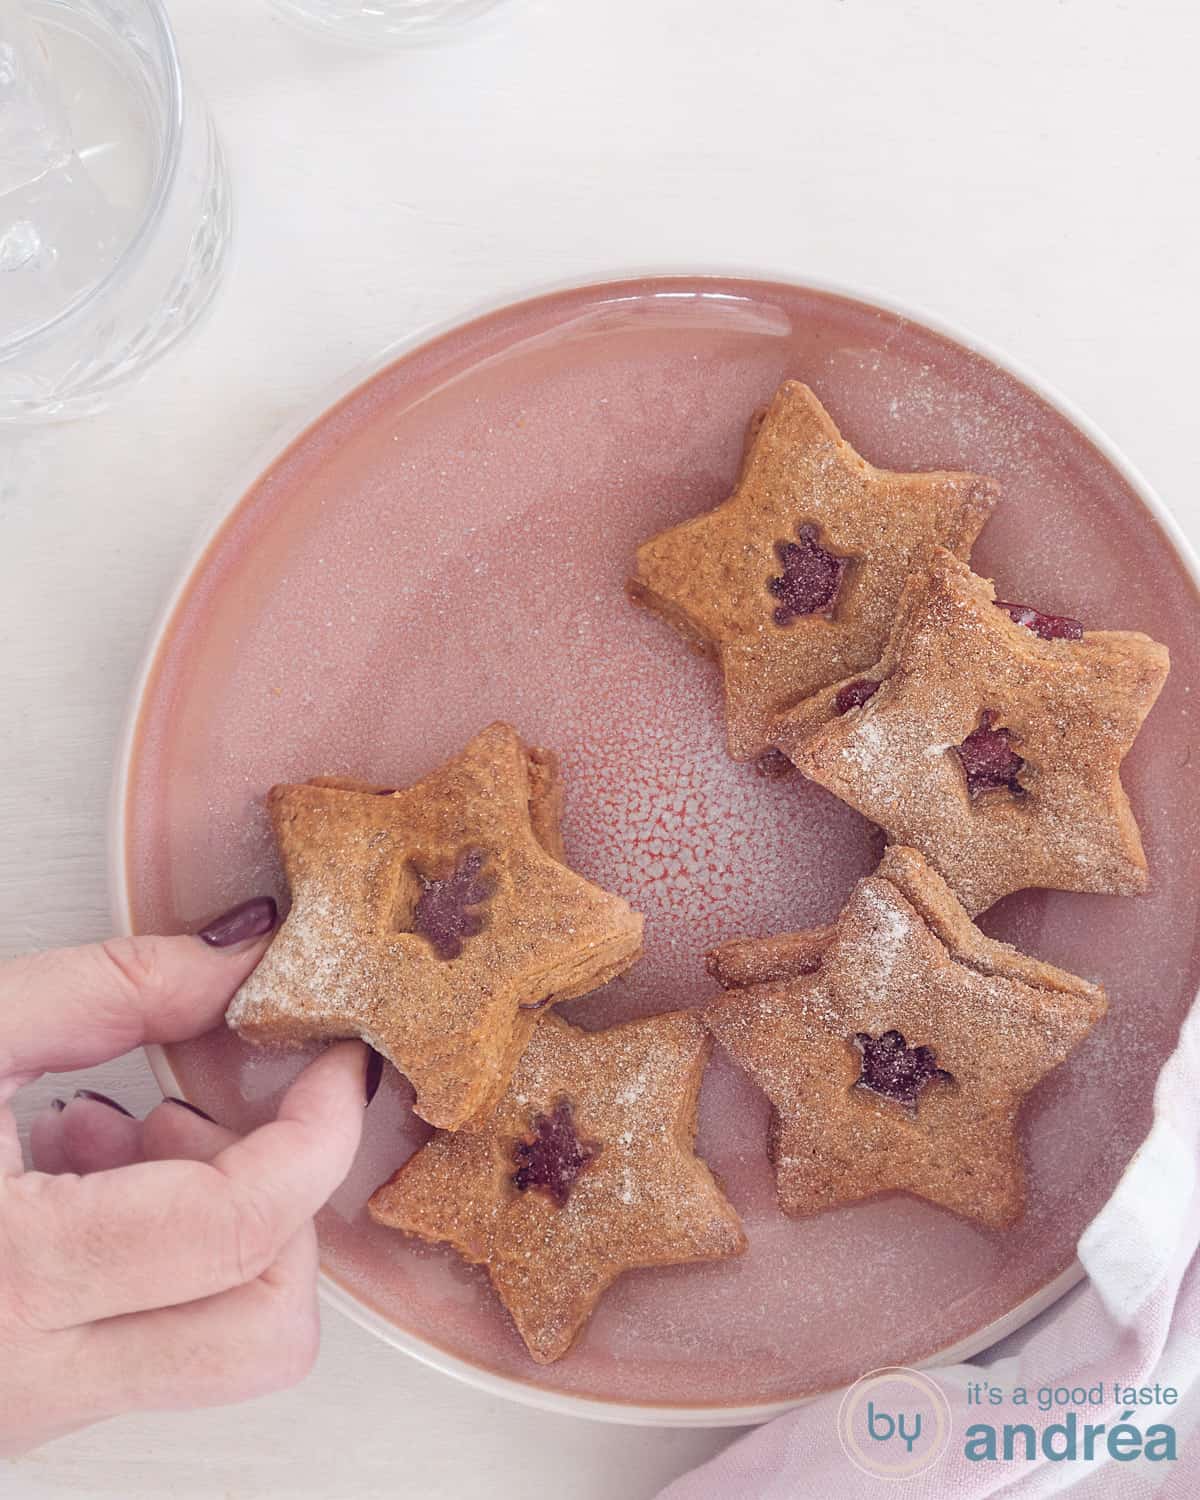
0 0 1200 1500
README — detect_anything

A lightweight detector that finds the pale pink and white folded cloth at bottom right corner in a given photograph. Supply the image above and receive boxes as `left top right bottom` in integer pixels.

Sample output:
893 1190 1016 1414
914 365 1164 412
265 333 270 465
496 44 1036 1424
660 1002 1200 1500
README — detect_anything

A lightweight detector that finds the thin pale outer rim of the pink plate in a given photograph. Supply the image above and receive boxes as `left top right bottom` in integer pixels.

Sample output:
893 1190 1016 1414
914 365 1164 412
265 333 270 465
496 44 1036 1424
105 263 1200 1428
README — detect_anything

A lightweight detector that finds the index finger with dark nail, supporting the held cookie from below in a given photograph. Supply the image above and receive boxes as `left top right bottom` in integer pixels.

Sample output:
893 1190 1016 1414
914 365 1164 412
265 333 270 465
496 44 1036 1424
0 1043 366 1331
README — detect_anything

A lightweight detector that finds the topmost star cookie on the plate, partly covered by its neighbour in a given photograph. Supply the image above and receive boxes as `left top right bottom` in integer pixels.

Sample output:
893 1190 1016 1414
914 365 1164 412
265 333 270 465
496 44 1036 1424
629 381 996 761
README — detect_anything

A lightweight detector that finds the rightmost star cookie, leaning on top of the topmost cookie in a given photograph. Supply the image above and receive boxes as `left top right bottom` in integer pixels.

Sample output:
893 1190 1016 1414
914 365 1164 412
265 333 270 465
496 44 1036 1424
776 548 1170 912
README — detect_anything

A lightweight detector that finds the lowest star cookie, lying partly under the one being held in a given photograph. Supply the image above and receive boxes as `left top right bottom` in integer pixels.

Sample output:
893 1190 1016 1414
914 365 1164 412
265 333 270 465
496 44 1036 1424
369 1011 746 1364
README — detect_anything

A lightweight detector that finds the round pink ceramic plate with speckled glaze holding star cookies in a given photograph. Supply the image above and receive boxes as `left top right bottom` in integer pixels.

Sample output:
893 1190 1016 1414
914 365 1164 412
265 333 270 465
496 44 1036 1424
116 276 1200 1424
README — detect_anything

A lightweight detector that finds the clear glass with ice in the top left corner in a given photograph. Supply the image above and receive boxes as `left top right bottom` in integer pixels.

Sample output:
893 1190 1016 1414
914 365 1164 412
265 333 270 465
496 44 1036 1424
0 0 230 423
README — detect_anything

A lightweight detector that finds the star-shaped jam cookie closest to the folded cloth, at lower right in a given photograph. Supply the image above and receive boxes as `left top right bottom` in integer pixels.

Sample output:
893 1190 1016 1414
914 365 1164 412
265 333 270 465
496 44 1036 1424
707 846 1106 1229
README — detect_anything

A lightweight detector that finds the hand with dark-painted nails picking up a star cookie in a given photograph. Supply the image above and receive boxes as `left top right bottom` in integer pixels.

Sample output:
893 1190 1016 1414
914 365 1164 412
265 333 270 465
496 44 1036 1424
0 899 371 1455
